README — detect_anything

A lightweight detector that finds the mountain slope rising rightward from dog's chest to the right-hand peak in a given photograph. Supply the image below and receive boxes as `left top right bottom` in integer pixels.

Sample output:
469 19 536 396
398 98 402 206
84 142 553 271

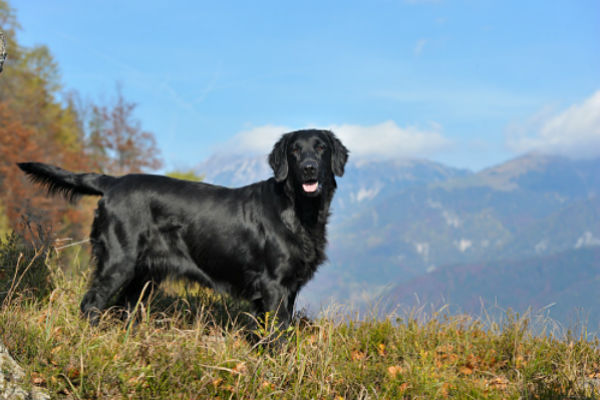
313 154 600 299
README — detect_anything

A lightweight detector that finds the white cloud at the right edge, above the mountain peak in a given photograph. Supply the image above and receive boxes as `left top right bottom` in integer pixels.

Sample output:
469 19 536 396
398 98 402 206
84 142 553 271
507 90 600 158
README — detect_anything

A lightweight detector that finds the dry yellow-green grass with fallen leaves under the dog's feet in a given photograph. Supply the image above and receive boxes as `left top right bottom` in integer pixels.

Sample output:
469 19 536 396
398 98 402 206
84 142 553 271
0 233 600 400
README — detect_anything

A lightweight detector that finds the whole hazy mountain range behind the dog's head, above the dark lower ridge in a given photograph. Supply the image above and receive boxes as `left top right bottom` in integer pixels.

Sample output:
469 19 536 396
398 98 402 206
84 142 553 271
200 154 600 324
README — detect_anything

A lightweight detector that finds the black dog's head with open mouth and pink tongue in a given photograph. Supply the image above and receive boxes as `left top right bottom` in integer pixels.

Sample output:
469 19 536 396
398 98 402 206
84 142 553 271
269 129 348 197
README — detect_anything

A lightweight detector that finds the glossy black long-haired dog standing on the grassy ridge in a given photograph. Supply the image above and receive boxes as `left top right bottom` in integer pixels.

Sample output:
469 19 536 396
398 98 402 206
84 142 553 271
18 130 348 327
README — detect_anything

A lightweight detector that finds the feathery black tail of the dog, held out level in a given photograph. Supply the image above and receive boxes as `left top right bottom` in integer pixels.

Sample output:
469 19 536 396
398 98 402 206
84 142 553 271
17 162 117 202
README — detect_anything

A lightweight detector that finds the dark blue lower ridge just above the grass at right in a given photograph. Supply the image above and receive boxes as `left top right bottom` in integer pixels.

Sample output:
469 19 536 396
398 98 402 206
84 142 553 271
380 246 600 332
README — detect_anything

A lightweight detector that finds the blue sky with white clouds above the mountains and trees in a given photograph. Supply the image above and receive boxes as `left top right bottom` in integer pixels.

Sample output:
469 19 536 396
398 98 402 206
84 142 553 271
10 0 600 173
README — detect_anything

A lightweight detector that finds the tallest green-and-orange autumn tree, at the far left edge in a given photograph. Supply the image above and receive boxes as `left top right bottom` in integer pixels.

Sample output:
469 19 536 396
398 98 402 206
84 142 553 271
0 0 86 236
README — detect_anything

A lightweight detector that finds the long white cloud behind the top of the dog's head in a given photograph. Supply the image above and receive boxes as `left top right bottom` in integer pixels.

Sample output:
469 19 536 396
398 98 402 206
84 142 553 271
220 121 451 161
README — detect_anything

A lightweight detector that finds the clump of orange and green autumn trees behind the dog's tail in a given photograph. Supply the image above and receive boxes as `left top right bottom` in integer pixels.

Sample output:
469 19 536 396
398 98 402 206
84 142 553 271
0 0 160 237
